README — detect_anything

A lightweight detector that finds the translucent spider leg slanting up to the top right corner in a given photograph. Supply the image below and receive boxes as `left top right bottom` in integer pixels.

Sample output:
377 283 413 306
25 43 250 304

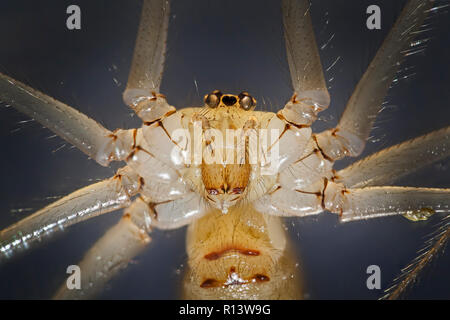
317 0 433 160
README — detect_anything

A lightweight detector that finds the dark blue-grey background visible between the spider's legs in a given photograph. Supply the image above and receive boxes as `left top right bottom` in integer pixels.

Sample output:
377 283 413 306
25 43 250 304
0 0 450 299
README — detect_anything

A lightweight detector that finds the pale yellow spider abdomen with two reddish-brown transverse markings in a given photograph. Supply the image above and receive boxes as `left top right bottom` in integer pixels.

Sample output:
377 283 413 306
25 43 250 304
183 205 302 299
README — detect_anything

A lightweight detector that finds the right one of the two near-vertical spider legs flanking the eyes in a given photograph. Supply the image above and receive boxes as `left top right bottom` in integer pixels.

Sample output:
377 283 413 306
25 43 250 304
279 0 330 125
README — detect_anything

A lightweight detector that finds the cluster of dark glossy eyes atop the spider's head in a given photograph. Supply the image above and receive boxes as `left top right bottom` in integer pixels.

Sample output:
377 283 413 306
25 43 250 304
204 90 256 111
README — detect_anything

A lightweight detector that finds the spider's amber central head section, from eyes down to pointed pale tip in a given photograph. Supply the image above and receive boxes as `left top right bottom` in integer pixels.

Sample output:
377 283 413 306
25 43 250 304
200 90 258 212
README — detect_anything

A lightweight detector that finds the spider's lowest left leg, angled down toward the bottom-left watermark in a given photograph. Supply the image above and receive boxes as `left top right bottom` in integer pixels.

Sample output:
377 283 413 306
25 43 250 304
54 194 200 299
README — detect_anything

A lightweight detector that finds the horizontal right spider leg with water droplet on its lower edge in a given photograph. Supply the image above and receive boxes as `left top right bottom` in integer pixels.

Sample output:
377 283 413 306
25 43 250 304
254 179 450 222
